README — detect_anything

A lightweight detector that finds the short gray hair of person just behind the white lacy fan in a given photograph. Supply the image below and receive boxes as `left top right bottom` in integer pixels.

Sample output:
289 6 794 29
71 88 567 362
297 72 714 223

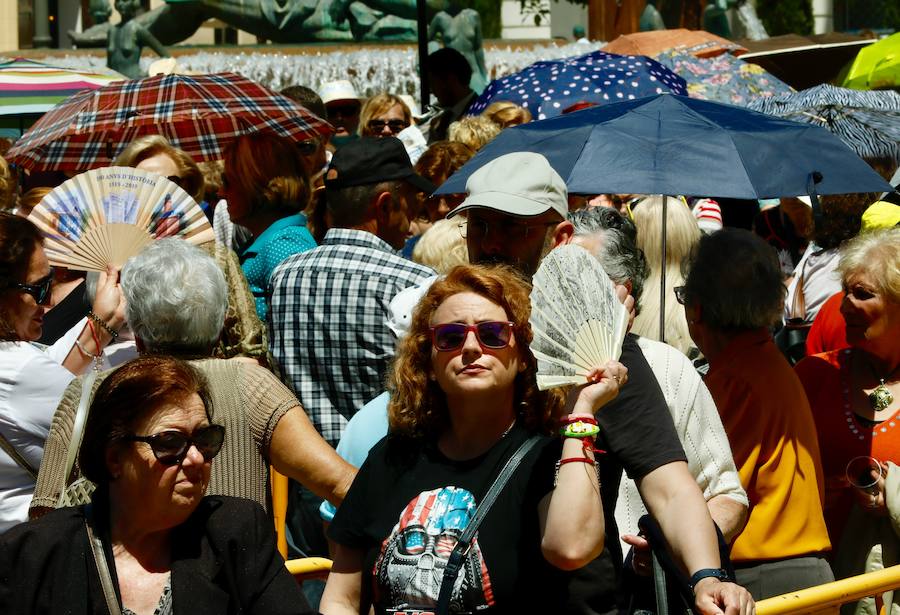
568 207 650 312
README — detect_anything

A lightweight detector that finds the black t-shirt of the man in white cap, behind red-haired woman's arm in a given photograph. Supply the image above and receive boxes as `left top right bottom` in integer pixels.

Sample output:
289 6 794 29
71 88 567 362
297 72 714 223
568 334 687 615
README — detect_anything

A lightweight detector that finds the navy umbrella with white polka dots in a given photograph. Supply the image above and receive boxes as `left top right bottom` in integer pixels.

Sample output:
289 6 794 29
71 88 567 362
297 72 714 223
469 51 687 120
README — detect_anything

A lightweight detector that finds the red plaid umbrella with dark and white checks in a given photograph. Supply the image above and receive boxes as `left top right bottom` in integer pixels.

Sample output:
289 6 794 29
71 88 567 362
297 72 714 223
7 73 332 171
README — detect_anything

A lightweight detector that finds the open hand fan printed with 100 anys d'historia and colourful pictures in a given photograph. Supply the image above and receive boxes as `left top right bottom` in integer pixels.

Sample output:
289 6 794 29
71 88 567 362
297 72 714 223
28 167 215 271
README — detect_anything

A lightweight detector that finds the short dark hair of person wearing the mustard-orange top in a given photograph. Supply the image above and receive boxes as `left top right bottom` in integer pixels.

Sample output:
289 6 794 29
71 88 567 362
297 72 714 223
684 228 787 331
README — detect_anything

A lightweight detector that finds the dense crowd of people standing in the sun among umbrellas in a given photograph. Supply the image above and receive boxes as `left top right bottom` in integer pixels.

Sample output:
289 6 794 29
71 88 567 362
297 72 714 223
0 44 900 615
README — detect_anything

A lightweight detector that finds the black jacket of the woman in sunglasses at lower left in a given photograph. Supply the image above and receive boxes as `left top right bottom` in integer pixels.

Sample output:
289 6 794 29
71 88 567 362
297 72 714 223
0 496 313 615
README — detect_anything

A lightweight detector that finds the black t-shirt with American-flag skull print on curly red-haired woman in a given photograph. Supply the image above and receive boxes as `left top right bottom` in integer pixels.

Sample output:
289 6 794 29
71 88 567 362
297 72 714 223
329 424 564 615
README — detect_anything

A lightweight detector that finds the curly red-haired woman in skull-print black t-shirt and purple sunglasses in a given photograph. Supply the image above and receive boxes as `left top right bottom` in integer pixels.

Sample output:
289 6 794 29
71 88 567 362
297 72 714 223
320 266 627 615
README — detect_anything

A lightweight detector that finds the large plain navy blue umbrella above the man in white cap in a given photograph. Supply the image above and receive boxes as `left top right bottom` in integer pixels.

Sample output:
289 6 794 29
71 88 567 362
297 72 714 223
438 94 891 199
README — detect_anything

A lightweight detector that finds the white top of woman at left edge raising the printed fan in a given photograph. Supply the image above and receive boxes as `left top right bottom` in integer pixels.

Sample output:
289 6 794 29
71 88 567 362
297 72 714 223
0 342 75 533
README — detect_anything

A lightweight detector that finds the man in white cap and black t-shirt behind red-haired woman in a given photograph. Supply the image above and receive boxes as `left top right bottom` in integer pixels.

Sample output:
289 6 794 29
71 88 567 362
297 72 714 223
447 152 752 615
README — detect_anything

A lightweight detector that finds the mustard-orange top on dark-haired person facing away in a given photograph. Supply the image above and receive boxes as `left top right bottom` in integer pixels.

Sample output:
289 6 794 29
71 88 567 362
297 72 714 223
706 330 831 562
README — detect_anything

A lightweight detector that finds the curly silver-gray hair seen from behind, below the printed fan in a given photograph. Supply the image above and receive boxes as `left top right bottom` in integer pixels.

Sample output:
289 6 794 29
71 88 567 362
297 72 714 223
122 238 228 354
